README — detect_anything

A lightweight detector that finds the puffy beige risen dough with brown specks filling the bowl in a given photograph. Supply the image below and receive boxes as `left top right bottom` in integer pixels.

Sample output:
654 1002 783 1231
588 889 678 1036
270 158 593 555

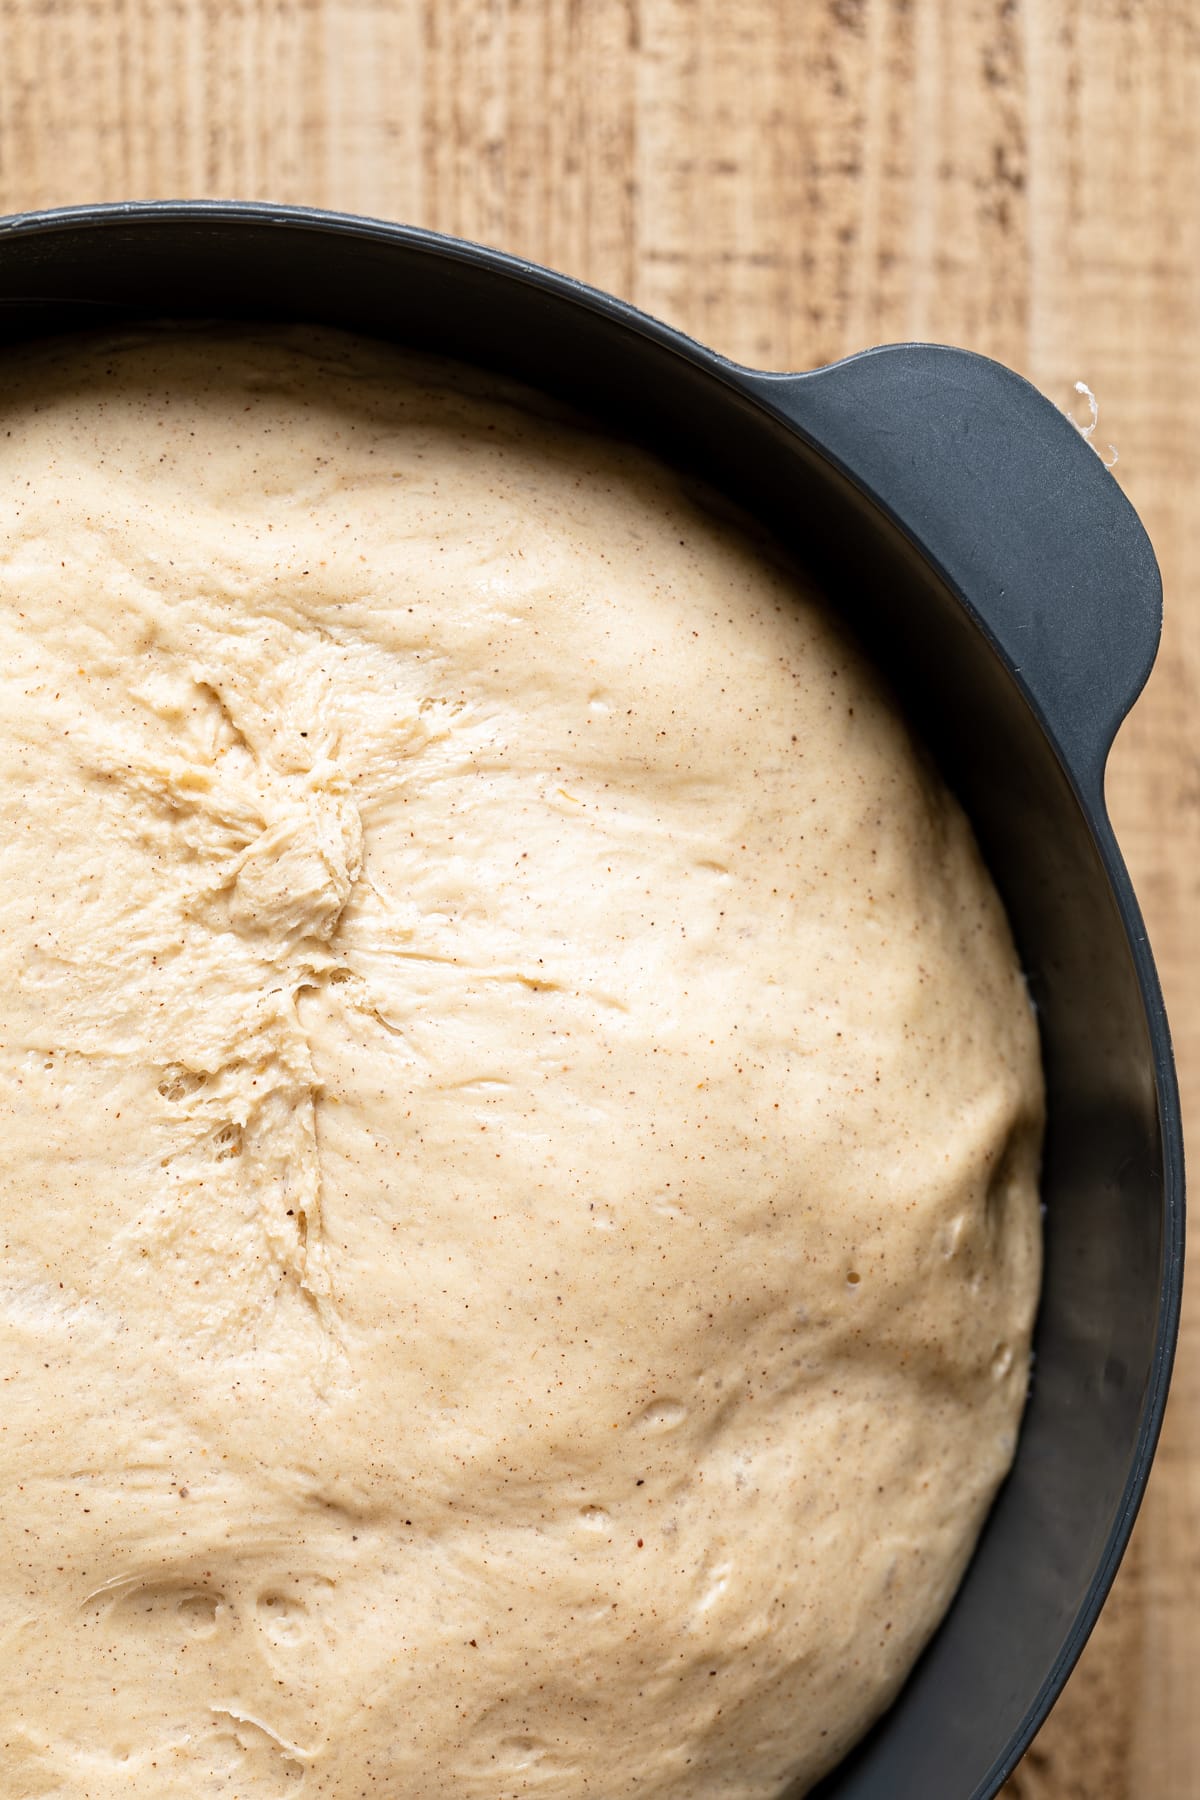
0 328 1042 1800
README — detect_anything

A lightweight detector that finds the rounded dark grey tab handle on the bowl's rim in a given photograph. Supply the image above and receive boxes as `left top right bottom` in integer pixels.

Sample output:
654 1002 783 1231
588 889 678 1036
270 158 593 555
750 344 1162 797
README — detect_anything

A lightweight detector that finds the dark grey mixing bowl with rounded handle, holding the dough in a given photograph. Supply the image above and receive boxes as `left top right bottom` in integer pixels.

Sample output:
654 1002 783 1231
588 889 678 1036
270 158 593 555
0 202 1184 1800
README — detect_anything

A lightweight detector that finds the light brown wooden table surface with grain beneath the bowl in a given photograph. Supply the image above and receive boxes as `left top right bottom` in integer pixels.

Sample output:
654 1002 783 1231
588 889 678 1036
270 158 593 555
0 0 1200 1800
